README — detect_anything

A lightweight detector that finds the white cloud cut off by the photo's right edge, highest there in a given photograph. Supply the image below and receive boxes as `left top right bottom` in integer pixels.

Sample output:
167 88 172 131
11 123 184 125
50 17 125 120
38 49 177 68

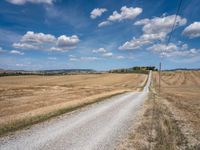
182 22 200 38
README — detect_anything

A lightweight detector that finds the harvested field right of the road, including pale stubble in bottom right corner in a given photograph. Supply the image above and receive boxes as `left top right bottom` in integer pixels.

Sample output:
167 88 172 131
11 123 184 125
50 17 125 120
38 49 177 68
154 71 200 149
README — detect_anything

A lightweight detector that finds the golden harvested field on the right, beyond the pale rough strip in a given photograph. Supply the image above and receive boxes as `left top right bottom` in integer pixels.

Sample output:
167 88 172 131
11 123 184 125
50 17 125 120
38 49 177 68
154 71 200 132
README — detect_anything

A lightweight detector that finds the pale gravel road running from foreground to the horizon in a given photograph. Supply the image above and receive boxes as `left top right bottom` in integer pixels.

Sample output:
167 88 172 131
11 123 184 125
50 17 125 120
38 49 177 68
0 72 151 150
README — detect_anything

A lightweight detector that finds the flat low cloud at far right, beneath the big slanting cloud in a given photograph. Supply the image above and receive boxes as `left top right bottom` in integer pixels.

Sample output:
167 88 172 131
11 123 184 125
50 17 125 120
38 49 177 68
148 43 200 57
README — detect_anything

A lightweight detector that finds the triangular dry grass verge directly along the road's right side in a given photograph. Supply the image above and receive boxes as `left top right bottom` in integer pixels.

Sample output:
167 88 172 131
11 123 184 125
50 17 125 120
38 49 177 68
117 88 189 150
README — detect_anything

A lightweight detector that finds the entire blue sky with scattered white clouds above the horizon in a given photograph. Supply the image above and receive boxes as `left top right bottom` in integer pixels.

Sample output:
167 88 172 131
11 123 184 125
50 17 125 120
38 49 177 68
0 0 200 70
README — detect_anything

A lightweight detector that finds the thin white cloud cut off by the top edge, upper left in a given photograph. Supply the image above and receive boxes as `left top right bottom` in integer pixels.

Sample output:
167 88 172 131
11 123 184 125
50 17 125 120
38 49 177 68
6 0 54 5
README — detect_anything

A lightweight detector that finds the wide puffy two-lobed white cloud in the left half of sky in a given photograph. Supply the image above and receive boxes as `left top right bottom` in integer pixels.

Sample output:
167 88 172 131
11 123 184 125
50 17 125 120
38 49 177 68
13 31 80 51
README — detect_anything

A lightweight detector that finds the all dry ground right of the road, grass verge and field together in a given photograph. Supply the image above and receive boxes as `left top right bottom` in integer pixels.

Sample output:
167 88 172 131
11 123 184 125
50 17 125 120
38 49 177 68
118 71 200 150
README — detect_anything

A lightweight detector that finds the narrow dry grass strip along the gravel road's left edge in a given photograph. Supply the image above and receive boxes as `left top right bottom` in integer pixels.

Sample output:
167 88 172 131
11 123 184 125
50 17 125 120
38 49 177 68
0 91 127 136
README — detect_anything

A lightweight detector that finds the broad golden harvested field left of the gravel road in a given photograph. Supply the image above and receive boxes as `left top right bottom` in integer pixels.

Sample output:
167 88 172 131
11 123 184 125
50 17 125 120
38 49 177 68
0 74 146 133
